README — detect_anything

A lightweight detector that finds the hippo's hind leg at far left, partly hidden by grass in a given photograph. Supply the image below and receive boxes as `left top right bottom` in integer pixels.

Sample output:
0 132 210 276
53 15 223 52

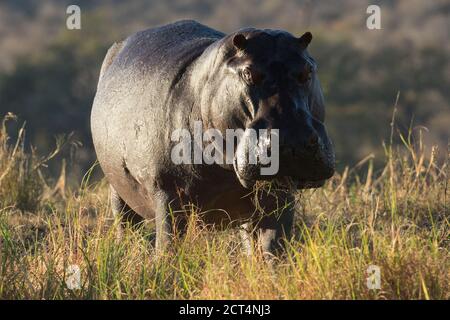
110 186 143 239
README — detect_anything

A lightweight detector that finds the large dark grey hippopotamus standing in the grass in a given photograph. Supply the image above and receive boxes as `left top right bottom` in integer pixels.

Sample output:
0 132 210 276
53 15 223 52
91 21 335 254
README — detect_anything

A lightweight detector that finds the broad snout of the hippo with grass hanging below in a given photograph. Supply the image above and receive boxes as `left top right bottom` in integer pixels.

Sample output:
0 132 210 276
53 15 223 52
234 123 335 189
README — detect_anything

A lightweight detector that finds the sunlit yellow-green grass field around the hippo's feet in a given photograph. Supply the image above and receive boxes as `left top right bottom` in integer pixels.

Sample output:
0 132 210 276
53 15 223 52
0 114 450 299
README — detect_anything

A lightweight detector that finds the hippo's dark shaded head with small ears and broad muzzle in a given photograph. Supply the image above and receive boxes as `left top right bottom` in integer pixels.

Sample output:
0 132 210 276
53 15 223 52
200 29 334 188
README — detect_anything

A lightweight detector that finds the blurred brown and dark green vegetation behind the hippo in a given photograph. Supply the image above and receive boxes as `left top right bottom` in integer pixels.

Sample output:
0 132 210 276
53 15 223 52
0 0 450 182
